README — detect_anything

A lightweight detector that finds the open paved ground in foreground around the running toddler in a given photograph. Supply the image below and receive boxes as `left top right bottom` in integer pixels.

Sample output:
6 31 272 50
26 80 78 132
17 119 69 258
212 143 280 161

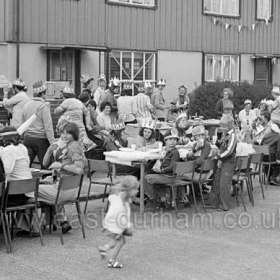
0 179 280 280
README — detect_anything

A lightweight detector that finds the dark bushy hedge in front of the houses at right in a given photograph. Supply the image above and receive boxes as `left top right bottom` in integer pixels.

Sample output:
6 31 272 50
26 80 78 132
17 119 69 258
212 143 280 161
189 81 273 119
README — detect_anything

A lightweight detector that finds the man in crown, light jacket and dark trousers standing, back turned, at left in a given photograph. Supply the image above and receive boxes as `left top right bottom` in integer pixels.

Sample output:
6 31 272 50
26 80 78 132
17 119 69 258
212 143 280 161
22 81 54 168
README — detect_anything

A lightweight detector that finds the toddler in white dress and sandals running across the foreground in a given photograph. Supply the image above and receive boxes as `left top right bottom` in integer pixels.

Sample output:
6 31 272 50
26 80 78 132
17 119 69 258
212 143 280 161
98 176 139 268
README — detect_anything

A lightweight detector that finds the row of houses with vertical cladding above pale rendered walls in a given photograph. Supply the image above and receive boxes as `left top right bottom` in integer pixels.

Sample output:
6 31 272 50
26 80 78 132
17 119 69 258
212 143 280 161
0 0 280 102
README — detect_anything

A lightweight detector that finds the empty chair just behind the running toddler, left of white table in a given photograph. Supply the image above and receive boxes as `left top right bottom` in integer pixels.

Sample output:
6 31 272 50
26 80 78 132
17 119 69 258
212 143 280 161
84 159 118 213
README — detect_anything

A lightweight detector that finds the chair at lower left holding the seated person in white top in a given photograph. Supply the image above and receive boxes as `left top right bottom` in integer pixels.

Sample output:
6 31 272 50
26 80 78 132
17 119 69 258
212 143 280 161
2 178 44 252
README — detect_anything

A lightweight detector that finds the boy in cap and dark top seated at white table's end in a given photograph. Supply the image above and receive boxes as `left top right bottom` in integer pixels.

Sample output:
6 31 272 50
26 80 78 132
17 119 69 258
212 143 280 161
145 129 180 208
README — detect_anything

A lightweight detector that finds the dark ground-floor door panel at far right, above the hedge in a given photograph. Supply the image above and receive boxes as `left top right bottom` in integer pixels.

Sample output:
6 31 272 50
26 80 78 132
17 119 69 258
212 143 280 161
255 58 272 84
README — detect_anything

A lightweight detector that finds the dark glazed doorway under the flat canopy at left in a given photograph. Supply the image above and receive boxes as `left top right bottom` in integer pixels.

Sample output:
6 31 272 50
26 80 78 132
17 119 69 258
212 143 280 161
48 51 74 84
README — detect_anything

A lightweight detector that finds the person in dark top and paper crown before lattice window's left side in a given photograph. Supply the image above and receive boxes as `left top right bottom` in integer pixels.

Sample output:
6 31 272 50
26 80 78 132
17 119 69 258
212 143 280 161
105 77 121 123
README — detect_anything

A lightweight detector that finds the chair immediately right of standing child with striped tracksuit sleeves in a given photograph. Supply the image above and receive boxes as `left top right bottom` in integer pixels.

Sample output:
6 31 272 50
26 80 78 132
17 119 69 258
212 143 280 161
232 156 254 211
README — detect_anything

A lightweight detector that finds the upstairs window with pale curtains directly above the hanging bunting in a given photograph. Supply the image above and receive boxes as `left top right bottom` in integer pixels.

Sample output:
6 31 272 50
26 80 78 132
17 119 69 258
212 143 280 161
203 0 240 17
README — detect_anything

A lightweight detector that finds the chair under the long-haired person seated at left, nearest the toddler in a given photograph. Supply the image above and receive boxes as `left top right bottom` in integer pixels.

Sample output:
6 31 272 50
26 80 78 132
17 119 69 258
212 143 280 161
44 174 86 245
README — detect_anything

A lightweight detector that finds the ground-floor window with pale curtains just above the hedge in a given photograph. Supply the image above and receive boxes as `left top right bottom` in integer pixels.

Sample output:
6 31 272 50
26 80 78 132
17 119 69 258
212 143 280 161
205 54 239 82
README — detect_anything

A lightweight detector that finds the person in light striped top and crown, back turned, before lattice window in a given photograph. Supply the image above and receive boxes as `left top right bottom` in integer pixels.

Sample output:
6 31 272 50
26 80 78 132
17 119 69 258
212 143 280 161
134 83 153 120
